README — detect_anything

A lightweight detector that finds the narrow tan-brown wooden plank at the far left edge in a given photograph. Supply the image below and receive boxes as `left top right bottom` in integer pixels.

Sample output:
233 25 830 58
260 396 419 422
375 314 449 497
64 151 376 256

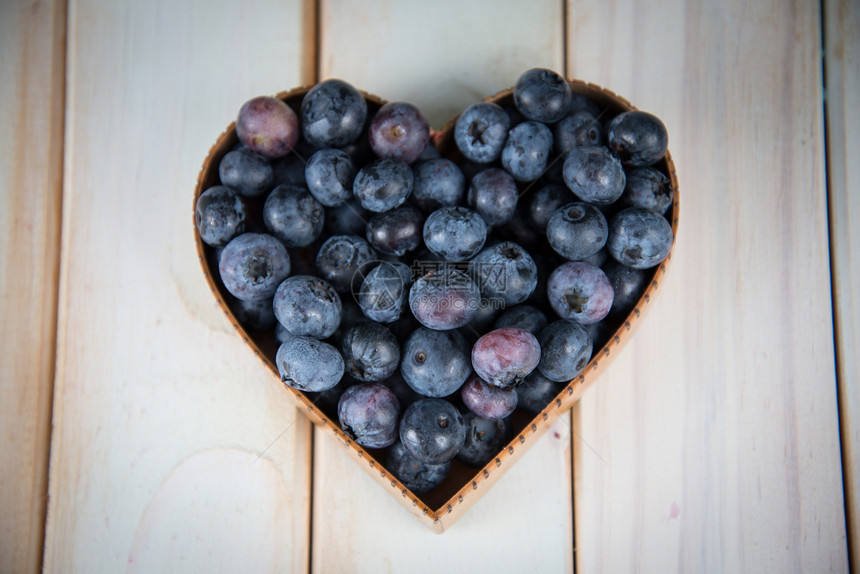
0 0 66 572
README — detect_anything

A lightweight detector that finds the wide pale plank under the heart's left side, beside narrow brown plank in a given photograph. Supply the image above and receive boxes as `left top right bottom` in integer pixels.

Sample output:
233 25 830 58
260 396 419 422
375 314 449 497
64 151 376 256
45 0 311 572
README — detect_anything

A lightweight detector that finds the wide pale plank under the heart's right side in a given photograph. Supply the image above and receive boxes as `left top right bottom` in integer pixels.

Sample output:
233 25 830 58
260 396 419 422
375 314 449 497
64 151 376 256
568 0 848 572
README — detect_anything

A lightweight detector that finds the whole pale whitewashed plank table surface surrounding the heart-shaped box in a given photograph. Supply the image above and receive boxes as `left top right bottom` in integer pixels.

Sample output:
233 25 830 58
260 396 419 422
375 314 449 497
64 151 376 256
0 0 860 573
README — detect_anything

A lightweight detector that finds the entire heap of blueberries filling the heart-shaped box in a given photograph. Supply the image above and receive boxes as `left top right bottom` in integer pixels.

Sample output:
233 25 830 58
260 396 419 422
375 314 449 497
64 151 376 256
195 69 673 500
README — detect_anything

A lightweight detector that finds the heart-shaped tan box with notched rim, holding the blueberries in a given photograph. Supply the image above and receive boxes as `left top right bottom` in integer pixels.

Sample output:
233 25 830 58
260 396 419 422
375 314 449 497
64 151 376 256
192 80 679 532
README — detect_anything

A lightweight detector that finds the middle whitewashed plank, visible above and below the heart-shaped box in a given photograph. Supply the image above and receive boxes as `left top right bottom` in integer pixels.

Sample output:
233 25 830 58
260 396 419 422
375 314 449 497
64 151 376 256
311 1 572 572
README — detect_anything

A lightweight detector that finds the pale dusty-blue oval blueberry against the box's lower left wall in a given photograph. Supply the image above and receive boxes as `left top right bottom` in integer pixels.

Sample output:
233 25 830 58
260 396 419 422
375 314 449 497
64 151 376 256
275 335 344 392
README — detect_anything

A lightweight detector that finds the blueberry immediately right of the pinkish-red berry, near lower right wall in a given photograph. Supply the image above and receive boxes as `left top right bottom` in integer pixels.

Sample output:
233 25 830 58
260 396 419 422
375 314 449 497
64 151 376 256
538 319 592 383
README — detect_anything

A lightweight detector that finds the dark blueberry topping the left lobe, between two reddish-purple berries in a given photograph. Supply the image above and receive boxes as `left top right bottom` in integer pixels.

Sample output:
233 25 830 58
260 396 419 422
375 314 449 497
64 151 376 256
300 79 367 147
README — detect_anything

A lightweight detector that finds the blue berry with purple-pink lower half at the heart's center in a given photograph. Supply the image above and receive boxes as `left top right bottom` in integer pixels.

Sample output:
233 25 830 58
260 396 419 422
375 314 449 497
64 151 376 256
409 265 481 330
